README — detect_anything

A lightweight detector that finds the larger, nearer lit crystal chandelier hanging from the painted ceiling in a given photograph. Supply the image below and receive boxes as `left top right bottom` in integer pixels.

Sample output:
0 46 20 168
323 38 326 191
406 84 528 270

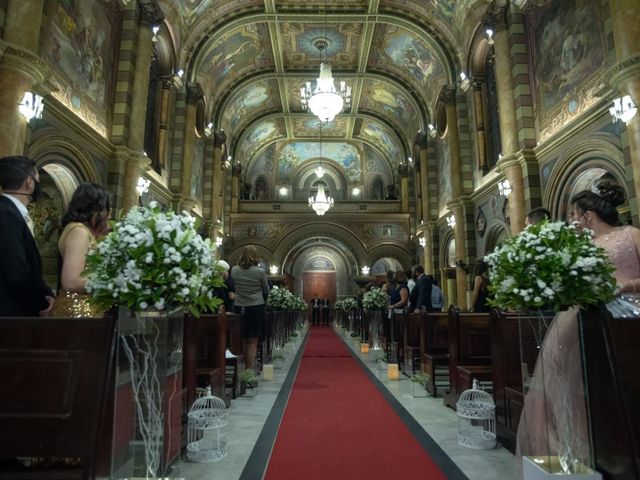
300 1 351 122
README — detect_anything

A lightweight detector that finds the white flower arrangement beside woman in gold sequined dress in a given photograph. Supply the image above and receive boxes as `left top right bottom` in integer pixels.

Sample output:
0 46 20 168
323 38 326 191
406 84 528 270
84 202 223 316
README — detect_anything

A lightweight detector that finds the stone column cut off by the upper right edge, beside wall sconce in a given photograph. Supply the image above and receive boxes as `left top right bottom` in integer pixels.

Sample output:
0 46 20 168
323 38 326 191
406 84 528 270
609 0 640 214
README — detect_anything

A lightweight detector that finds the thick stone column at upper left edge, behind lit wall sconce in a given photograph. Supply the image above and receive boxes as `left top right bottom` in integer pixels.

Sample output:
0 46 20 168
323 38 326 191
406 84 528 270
0 0 50 157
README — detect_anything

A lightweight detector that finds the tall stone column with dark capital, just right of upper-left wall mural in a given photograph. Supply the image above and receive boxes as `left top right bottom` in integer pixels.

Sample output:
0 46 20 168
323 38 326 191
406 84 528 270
122 3 164 212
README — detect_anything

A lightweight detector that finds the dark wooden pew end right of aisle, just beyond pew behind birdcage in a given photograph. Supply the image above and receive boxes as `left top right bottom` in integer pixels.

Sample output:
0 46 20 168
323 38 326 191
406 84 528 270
420 312 449 397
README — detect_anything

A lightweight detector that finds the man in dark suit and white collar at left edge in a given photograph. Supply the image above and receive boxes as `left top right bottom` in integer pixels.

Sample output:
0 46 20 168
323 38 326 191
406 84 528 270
0 156 54 317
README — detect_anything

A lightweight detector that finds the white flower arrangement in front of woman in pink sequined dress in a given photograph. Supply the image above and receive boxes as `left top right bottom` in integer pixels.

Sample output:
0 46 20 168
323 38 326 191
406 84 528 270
485 221 616 311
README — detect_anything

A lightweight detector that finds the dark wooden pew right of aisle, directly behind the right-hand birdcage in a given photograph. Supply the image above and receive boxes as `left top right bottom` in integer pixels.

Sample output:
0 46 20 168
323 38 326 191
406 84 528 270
443 307 491 409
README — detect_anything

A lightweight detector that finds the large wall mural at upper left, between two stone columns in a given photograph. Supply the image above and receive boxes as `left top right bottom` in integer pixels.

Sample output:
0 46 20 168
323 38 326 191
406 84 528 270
42 0 119 135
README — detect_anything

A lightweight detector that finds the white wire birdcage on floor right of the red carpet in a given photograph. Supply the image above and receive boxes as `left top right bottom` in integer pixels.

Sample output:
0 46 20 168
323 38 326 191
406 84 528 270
456 379 496 450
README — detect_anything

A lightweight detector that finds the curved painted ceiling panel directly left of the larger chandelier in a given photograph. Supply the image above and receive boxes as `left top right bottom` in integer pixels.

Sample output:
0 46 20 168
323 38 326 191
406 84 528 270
221 80 280 132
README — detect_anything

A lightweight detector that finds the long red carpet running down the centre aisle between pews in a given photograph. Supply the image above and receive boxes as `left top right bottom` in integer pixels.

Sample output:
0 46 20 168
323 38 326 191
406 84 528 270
265 327 447 480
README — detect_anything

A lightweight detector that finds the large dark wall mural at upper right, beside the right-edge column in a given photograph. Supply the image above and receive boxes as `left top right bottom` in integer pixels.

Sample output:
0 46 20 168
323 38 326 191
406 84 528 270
529 0 604 122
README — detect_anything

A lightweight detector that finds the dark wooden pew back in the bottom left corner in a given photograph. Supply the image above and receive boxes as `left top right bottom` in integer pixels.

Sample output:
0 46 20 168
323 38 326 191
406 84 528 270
0 316 116 479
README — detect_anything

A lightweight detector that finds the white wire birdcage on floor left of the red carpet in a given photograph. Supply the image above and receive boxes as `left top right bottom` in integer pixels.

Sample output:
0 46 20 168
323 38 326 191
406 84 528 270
187 387 228 463
